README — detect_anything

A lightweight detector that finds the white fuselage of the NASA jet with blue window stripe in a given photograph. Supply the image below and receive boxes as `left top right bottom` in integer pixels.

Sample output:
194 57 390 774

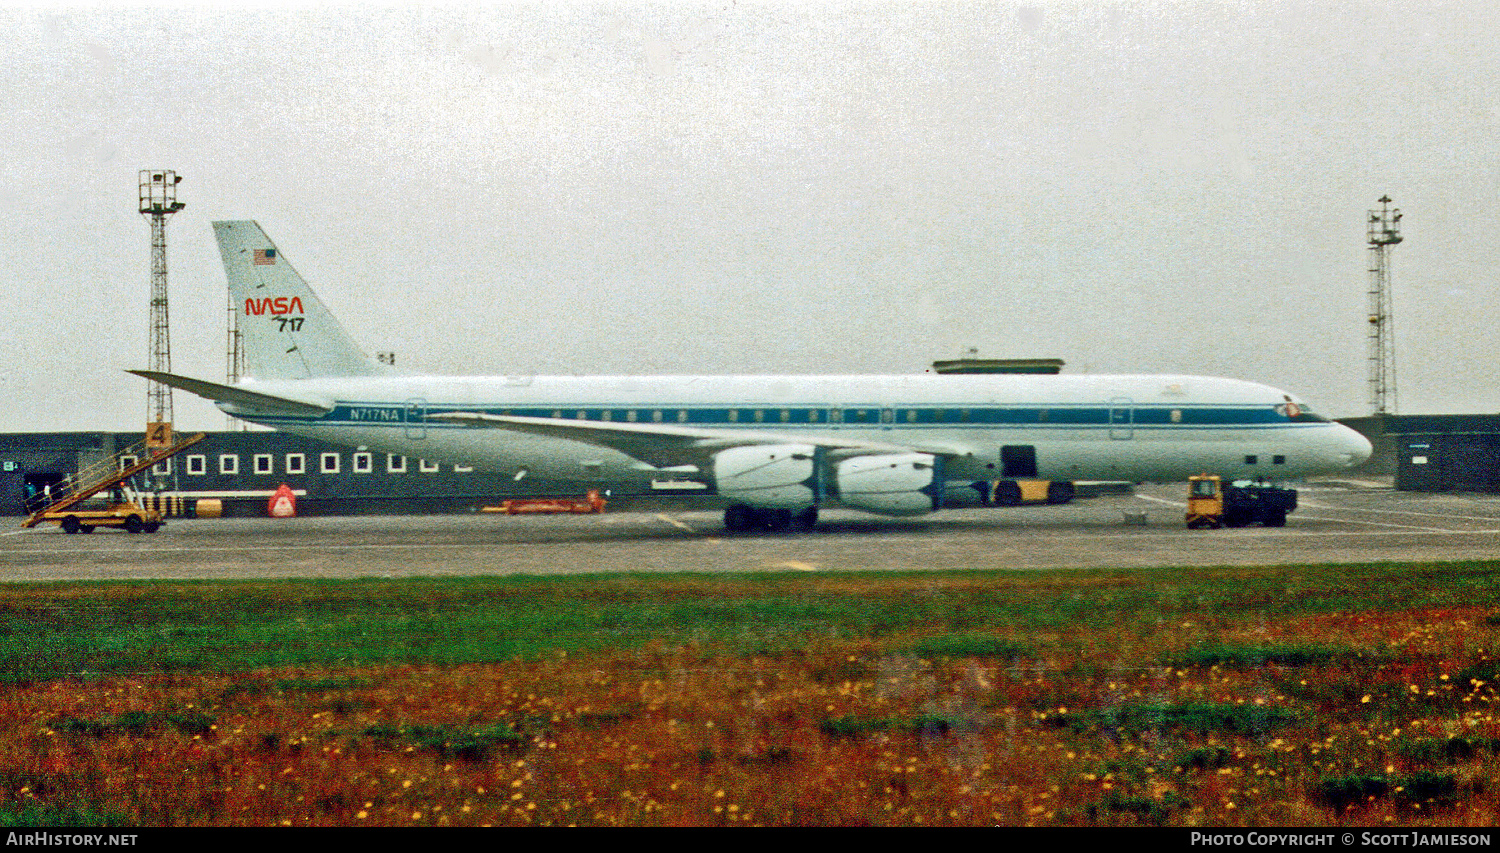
231 375 1370 487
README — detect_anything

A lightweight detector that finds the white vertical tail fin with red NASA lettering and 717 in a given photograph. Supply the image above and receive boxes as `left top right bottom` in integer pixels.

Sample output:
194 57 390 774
213 220 386 379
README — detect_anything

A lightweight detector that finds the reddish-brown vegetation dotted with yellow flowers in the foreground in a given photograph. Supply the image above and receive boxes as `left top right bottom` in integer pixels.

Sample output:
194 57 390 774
0 599 1500 826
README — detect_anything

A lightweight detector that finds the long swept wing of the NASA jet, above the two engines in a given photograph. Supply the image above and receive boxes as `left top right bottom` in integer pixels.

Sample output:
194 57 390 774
428 412 977 469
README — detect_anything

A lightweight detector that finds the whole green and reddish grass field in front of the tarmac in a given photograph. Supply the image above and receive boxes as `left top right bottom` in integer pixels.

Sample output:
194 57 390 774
0 562 1500 826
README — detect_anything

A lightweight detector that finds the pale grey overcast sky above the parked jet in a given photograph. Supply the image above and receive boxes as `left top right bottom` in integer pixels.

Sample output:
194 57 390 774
0 0 1500 432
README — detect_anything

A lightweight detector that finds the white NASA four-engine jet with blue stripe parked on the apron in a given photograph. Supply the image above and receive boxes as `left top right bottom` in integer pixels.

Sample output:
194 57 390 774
131 220 1371 532
